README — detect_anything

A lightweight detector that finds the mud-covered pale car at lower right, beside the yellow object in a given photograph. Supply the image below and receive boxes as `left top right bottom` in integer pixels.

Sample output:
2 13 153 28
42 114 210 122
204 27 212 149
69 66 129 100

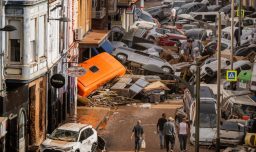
220 119 245 146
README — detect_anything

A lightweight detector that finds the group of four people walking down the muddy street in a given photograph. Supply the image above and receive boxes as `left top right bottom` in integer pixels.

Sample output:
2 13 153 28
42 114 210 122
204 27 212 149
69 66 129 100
131 113 189 152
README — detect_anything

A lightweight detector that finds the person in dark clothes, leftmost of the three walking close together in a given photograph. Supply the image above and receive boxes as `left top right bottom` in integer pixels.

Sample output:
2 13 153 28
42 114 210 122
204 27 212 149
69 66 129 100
156 113 167 149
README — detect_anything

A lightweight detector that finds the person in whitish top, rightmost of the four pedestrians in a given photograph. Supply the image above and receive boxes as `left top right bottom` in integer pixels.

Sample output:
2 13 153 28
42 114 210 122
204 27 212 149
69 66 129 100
178 118 189 152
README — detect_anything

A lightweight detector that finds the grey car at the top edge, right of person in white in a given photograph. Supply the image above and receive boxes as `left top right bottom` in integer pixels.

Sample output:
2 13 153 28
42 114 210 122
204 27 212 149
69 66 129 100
177 2 208 15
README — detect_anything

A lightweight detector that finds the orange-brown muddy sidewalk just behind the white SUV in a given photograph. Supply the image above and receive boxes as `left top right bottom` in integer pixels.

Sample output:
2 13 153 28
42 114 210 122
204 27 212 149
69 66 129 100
77 107 111 130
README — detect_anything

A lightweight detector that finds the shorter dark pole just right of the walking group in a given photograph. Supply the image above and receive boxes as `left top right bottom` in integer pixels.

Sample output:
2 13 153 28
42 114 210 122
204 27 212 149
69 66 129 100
195 58 200 152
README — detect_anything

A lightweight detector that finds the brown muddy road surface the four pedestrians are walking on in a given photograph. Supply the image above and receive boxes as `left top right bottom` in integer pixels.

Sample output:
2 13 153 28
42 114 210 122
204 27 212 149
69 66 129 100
99 102 214 152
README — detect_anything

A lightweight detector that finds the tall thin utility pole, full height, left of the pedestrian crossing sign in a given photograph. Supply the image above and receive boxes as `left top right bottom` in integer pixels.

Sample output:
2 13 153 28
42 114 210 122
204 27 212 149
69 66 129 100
216 12 221 152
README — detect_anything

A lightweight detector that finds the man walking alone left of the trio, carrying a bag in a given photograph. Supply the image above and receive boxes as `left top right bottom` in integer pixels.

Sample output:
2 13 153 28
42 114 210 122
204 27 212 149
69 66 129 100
131 120 144 152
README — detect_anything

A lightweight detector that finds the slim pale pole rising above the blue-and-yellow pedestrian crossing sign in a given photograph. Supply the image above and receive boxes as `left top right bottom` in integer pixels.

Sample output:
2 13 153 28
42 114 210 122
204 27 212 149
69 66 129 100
230 0 234 70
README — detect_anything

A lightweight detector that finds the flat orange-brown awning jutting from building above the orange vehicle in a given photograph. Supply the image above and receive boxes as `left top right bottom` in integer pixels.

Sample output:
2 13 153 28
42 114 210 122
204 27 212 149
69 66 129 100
79 30 109 48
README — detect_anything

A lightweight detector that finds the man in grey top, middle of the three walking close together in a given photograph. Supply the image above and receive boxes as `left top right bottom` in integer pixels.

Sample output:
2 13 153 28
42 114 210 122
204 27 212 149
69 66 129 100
163 117 175 152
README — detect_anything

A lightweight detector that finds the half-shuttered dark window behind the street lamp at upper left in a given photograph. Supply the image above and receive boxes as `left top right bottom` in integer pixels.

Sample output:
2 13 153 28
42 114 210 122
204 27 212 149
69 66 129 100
9 20 23 62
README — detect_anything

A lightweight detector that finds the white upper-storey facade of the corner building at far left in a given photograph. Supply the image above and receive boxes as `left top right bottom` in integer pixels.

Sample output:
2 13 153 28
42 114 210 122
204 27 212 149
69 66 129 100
5 0 65 81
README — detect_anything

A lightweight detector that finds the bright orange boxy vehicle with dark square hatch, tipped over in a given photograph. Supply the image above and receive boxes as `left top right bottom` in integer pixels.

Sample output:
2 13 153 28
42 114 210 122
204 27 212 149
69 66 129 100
77 52 126 97
